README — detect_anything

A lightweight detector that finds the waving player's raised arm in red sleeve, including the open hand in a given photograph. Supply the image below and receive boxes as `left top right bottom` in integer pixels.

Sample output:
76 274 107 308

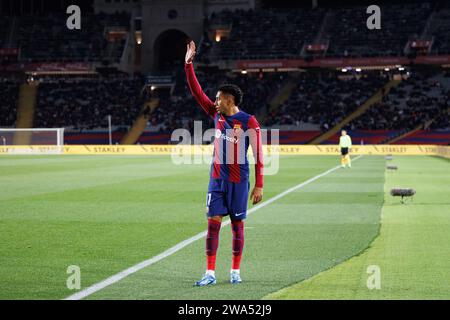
184 41 216 117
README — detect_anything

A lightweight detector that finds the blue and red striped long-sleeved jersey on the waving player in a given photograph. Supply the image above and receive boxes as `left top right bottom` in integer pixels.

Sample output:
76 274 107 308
185 63 264 188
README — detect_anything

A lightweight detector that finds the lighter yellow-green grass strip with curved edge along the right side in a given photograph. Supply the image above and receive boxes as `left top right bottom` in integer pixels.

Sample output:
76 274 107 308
265 157 450 299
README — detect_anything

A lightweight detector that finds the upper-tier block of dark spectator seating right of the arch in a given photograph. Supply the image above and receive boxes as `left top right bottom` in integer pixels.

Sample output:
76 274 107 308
199 2 436 62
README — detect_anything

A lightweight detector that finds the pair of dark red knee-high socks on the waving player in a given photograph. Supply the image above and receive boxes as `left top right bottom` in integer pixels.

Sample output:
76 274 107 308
206 219 244 271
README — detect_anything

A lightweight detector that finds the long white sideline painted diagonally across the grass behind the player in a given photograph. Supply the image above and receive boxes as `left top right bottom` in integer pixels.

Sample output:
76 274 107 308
64 155 362 300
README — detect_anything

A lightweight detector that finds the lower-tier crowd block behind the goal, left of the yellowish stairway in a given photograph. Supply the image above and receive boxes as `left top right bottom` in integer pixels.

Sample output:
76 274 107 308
35 77 145 129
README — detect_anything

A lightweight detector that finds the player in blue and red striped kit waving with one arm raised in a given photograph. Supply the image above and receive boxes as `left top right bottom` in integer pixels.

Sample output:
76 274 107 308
185 41 264 286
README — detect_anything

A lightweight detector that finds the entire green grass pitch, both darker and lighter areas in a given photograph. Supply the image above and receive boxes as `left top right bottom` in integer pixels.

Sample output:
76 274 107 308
0 156 450 299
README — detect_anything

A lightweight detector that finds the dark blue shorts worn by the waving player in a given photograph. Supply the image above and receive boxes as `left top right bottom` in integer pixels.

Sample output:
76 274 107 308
206 179 250 220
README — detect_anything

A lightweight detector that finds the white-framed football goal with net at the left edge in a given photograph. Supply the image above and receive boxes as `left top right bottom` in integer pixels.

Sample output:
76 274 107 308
0 128 64 154
